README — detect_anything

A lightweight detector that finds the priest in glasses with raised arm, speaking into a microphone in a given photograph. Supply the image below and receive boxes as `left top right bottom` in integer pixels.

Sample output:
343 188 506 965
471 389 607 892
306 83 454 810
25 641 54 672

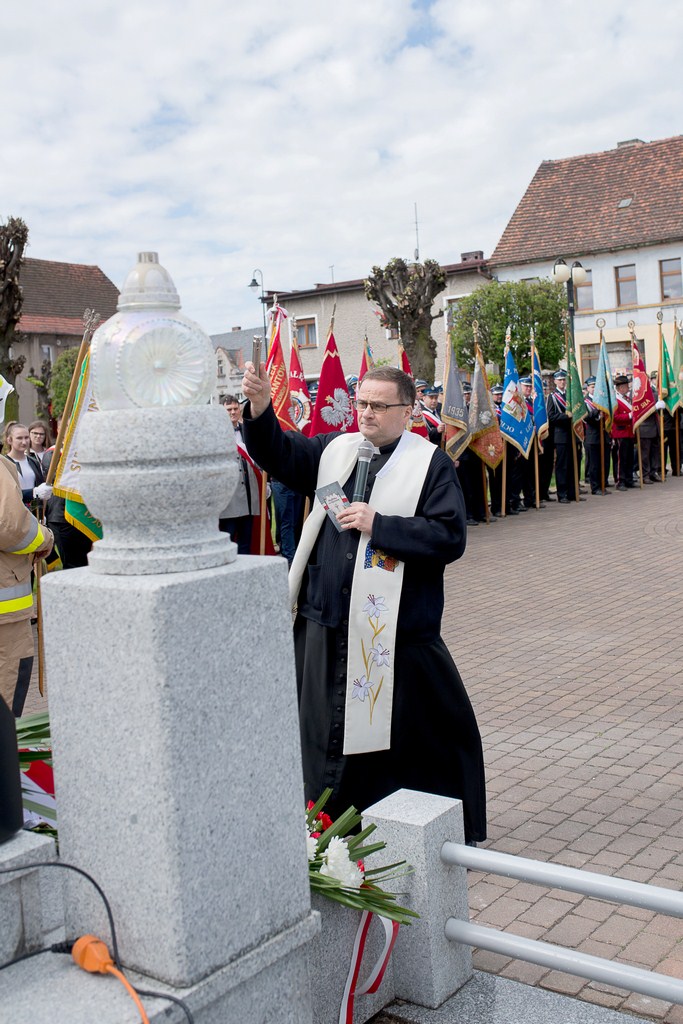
243 364 486 843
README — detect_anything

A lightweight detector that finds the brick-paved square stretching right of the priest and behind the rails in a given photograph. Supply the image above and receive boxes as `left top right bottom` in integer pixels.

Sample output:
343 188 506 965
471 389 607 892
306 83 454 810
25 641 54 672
443 478 683 1024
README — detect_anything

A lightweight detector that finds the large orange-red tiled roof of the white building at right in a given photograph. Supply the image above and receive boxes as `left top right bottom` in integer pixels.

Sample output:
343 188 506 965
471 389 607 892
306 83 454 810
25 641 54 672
488 135 683 265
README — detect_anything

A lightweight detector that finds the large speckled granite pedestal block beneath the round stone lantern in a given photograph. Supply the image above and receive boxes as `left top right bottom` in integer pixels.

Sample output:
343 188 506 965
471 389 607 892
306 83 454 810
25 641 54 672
42 557 310 986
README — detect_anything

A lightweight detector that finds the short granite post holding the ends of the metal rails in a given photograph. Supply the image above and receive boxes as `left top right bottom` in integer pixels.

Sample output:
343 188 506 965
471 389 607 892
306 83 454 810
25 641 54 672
362 790 472 1007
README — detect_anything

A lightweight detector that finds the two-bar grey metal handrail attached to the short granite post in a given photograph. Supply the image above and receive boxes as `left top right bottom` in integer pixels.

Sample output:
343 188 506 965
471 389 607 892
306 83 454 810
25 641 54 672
441 842 683 1004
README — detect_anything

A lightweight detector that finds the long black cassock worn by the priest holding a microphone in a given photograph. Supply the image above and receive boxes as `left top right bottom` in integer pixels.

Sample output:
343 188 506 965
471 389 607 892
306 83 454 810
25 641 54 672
244 407 486 842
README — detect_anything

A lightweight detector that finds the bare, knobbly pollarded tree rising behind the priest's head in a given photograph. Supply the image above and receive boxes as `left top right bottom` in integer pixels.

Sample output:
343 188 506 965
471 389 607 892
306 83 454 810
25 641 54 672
365 258 445 381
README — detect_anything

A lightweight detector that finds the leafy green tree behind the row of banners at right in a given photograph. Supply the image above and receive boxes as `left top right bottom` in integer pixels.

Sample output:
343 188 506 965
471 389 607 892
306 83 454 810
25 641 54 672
449 280 566 374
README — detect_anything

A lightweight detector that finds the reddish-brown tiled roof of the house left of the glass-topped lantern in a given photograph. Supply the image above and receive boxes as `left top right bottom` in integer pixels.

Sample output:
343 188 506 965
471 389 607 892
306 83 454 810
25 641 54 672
18 259 119 337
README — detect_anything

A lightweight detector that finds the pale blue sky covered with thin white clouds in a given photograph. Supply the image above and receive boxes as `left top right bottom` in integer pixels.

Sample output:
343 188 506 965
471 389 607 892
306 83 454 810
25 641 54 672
5 0 683 334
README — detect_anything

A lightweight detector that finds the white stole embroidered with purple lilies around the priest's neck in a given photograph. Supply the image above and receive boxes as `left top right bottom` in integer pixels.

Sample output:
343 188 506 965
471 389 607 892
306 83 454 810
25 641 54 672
290 431 436 755
